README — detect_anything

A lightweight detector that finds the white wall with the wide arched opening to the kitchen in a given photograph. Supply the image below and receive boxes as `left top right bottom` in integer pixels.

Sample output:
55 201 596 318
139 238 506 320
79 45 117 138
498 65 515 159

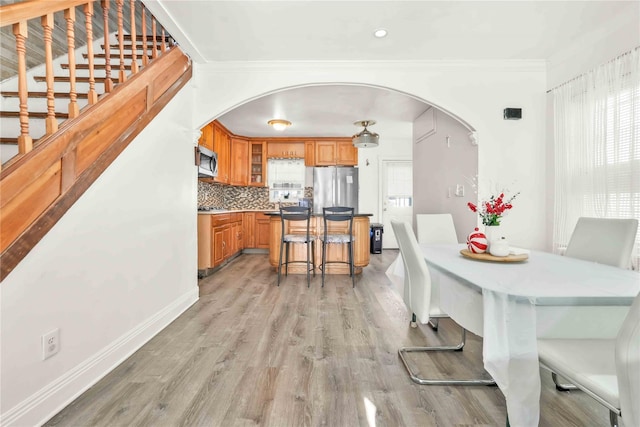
194 61 546 248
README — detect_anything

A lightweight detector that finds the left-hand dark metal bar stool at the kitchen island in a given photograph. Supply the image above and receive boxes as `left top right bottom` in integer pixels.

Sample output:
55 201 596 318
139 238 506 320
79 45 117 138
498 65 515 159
278 206 316 287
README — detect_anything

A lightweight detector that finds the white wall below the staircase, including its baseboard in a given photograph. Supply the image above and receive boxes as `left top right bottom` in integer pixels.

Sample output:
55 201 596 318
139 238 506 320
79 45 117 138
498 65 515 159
0 82 198 425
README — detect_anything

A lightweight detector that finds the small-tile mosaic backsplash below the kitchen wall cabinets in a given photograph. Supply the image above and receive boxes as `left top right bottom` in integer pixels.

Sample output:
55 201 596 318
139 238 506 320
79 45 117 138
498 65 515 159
198 181 313 210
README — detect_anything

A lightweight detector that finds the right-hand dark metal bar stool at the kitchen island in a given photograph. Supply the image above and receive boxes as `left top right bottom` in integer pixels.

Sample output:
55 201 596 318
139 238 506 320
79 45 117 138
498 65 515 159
320 206 356 288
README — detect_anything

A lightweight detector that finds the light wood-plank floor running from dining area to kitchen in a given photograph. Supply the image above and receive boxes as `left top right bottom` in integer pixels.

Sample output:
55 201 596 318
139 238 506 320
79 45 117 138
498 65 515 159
46 250 608 427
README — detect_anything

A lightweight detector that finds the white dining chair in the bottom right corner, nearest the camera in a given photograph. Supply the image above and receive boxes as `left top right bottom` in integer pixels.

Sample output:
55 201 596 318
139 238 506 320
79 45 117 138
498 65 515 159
538 294 640 427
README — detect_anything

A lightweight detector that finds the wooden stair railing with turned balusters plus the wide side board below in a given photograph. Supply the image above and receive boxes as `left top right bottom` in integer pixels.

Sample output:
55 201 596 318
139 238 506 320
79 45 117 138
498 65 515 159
0 0 192 281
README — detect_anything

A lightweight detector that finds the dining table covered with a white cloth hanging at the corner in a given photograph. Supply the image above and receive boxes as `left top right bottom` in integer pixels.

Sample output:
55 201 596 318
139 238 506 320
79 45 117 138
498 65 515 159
404 244 640 427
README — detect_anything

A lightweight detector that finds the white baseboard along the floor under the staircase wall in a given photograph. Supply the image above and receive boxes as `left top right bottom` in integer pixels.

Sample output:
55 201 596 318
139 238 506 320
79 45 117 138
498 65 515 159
0 287 198 427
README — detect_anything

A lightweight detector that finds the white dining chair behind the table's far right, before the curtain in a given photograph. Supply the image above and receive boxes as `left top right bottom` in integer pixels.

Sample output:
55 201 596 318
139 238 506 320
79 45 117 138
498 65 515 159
551 217 638 391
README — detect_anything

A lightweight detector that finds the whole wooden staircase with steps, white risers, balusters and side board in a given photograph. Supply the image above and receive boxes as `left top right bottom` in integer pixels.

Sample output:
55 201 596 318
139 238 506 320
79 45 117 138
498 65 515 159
0 0 192 281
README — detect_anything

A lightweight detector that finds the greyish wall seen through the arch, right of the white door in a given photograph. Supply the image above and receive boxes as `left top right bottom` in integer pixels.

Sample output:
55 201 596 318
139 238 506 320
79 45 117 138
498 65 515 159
413 111 478 242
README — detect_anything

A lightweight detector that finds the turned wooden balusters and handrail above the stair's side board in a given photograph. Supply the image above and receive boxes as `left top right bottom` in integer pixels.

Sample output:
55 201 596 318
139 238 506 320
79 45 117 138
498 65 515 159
0 0 173 167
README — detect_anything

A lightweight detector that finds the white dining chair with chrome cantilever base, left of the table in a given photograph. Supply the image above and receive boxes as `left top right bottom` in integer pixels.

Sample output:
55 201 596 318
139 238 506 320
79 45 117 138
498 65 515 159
391 220 495 385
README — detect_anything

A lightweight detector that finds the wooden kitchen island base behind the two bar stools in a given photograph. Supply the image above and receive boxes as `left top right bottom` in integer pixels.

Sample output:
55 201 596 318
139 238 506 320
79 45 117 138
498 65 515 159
267 213 372 274
